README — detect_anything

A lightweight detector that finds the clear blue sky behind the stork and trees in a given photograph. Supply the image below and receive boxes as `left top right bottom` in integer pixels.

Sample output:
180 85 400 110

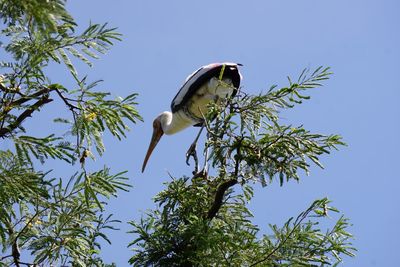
41 0 400 267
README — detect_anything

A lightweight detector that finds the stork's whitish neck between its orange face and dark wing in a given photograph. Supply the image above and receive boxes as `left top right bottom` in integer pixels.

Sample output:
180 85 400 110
162 110 193 135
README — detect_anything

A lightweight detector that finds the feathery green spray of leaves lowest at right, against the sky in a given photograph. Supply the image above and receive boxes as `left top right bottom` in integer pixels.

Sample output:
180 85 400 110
255 198 355 266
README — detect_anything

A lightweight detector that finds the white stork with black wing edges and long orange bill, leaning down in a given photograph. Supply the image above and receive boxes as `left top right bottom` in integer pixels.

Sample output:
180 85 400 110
142 62 242 172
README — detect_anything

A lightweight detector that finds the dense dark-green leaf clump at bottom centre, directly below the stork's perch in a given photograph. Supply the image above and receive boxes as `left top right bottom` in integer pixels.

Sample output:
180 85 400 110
130 178 258 266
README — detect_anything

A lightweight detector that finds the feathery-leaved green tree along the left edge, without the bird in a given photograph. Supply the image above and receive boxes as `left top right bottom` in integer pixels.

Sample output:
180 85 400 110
0 0 141 266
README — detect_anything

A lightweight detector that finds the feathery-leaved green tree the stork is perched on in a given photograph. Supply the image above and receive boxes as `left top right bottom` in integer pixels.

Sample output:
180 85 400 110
130 67 354 266
